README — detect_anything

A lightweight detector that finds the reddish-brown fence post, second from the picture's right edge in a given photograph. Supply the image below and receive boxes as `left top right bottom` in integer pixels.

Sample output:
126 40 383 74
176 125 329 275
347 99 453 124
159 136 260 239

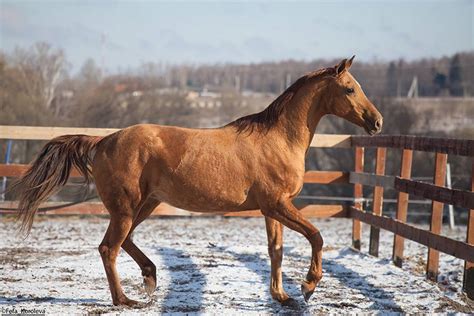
426 153 448 282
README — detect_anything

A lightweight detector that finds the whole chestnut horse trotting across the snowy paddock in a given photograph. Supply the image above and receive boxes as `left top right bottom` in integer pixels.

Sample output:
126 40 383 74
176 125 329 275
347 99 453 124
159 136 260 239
14 57 382 306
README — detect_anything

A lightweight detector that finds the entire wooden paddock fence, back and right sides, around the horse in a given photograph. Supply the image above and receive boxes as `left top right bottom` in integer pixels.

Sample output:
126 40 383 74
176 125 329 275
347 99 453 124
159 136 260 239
0 126 474 299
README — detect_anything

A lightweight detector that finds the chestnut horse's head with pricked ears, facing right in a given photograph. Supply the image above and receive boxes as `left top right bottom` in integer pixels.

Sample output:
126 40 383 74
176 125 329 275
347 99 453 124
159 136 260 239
320 56 383 135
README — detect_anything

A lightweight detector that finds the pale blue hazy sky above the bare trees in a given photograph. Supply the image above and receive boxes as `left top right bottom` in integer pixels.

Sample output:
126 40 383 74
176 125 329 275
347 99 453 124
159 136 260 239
0 0 474 70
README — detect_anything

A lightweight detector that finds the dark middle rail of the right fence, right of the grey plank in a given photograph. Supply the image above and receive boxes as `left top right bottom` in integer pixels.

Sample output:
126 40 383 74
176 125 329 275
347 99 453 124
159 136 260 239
395 178 474 208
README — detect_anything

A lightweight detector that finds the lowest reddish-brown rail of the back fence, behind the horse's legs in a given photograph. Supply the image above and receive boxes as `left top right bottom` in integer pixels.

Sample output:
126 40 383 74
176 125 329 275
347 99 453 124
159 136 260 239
0 201 347 218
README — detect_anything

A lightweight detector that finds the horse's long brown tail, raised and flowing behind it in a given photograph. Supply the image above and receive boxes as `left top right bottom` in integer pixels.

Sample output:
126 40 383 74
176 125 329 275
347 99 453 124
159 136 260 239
9 135 102 236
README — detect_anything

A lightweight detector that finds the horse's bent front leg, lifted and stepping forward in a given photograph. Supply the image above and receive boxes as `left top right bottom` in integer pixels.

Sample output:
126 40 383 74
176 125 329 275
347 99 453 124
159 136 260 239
262 199 323 301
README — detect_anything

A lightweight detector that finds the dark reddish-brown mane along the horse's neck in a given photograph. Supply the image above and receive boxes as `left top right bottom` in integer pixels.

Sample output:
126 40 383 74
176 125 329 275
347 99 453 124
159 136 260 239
228 67 335 133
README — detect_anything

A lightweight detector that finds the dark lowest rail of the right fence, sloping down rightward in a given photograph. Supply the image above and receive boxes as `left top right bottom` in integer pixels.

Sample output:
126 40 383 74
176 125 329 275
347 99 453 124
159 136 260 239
349 207 474 261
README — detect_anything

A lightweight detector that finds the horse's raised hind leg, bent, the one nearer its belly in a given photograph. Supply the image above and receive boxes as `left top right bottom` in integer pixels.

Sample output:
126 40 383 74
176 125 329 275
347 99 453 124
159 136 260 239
122 198 160 295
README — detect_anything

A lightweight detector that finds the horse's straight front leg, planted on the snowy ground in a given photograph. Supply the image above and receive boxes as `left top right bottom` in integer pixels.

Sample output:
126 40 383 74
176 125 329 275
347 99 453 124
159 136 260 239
265 217 297 307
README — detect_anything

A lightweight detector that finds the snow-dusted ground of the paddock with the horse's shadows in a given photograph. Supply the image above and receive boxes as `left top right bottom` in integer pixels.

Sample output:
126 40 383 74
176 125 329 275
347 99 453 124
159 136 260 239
0 217 474 314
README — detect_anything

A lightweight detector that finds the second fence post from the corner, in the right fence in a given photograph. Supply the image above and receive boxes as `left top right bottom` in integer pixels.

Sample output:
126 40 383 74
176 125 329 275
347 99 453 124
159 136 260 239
369 147 387 257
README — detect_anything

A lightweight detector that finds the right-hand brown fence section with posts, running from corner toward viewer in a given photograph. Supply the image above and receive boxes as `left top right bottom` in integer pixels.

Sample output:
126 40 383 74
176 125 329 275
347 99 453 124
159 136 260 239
348 136 474 299
